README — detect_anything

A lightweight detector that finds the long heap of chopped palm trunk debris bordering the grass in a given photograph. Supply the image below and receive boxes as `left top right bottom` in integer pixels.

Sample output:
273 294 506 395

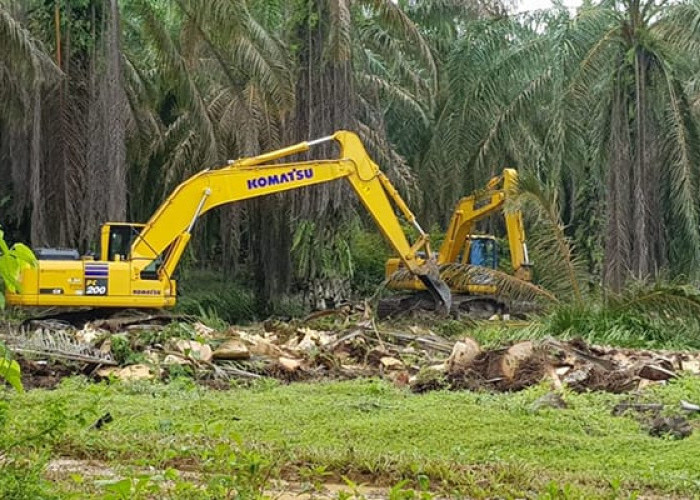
8 318 700 393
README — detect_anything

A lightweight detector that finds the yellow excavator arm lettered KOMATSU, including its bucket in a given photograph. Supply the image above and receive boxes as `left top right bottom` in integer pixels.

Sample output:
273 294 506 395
130 131 450 310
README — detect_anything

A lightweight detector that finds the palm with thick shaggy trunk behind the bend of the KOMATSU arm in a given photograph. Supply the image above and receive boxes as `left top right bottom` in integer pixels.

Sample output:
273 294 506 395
289 0 466 304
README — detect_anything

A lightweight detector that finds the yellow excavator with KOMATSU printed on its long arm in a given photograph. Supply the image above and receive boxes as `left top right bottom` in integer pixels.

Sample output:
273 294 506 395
6 131 451 311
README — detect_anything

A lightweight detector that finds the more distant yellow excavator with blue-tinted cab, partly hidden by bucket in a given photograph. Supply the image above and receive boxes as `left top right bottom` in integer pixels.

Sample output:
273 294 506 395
378 168 532 318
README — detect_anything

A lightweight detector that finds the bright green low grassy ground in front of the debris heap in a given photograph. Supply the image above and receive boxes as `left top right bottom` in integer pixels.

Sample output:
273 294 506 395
0 377 700 498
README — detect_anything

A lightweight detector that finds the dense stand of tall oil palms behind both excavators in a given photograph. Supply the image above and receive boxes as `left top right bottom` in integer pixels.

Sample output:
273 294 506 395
0 0 700 310
